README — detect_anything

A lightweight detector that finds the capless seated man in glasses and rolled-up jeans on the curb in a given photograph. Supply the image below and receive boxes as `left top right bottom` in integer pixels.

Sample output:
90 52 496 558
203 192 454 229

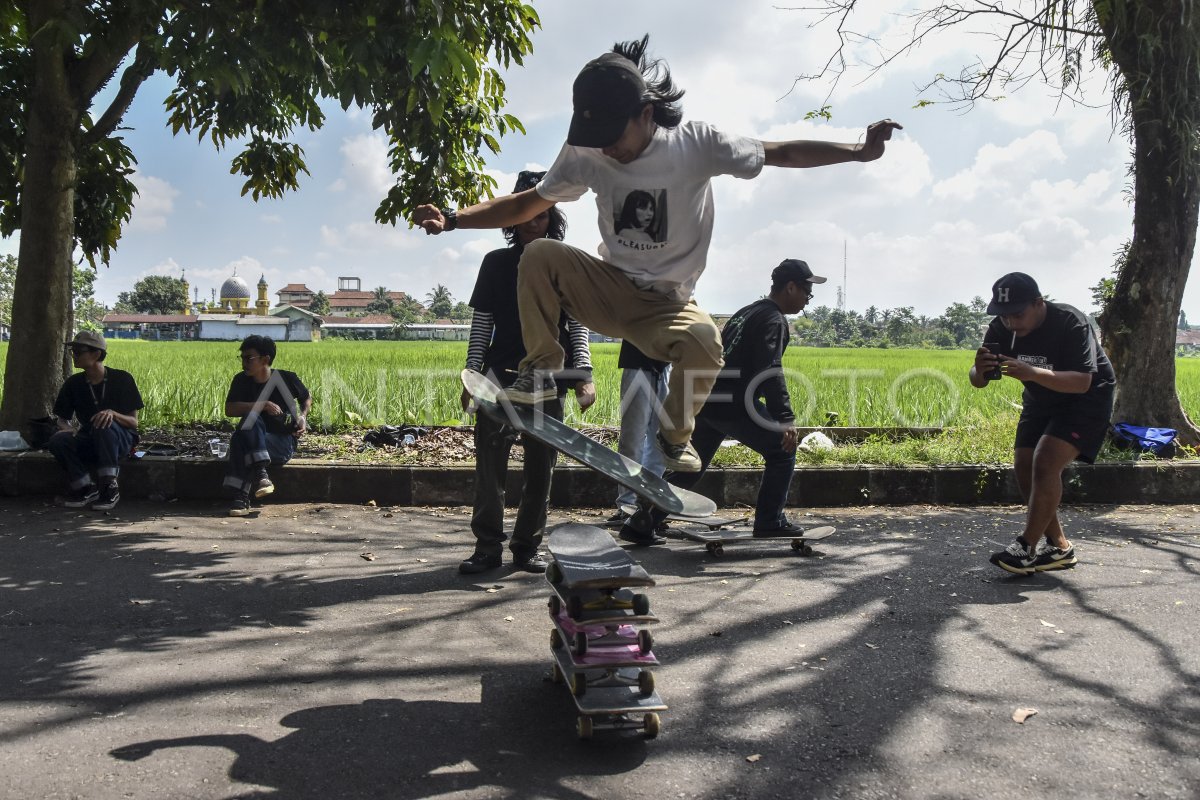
224 335 312 517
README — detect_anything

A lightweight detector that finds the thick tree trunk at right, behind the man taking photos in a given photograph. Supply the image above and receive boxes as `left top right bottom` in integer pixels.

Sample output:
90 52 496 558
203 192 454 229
1102 0 1200 446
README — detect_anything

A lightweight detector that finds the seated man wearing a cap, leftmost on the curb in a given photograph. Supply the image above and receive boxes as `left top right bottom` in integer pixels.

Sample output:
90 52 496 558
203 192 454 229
47 331 144 511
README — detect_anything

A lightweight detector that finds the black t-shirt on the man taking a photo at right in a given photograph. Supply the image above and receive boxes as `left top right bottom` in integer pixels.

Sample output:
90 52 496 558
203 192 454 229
983 302 1117 415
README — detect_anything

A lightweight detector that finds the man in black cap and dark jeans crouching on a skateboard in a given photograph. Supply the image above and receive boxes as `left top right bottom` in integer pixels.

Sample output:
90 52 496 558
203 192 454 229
619 258 826 545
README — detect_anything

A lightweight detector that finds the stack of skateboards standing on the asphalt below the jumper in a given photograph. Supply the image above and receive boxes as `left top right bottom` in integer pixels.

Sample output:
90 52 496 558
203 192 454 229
546 524 667 739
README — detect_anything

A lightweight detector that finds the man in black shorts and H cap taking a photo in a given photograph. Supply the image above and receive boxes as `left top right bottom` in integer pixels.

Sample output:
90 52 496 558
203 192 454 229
970 272 1116 575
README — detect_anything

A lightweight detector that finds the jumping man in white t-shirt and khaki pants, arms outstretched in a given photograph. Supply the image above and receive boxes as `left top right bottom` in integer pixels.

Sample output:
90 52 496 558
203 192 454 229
413 36 900 473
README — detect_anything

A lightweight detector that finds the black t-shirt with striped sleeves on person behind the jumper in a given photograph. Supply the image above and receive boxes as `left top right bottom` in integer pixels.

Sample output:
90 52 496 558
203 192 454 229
469 247 575 385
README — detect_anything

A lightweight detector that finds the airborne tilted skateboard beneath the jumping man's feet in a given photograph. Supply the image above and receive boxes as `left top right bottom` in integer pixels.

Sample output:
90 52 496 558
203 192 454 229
462 369 716 517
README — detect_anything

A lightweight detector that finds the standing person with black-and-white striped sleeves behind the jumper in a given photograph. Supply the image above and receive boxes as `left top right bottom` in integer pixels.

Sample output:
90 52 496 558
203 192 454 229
458 172 596 575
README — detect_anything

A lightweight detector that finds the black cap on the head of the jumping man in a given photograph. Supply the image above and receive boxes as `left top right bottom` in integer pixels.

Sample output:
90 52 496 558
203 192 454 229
566 53 646 148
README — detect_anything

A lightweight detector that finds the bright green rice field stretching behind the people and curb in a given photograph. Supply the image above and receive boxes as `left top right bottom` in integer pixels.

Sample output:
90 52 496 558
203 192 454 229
0 339 1200 435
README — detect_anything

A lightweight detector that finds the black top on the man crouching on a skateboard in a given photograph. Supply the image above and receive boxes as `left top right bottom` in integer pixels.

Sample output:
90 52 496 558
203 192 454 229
704 297 796 422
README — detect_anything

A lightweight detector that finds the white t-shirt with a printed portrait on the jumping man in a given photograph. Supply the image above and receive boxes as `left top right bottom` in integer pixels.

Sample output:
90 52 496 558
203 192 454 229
538 122 766 301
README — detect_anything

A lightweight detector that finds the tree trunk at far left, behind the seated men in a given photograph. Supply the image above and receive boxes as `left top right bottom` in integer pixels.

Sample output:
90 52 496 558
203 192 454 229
0 32 79 432
